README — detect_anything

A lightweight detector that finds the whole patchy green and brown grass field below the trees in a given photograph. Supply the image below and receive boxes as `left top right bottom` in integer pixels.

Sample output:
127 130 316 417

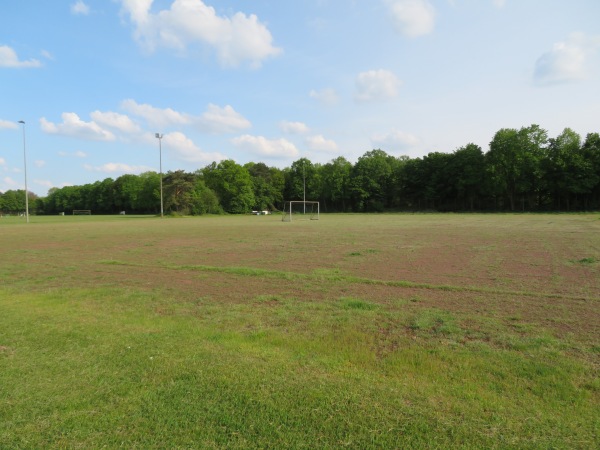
0 214 600 449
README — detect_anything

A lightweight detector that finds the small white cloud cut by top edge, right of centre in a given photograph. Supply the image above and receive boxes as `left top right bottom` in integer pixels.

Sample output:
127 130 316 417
385 0 435 38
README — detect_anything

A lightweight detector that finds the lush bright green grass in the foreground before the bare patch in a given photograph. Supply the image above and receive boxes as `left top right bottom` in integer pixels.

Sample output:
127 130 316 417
0 289 600 448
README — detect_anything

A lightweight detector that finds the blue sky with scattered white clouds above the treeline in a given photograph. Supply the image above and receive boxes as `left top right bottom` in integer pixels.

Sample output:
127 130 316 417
0 0 600 196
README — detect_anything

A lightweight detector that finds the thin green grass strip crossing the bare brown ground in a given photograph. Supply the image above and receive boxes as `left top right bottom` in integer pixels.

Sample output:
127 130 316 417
98 260 600 302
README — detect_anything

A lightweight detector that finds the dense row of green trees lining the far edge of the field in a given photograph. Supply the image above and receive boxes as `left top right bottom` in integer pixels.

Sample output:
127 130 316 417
0 125 600 215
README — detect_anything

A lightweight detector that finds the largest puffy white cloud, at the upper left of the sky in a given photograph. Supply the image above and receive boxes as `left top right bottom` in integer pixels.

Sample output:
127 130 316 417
121 0 281 67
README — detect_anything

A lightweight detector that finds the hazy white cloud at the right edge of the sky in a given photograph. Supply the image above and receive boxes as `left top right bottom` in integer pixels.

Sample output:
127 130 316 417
533 33 600 85
